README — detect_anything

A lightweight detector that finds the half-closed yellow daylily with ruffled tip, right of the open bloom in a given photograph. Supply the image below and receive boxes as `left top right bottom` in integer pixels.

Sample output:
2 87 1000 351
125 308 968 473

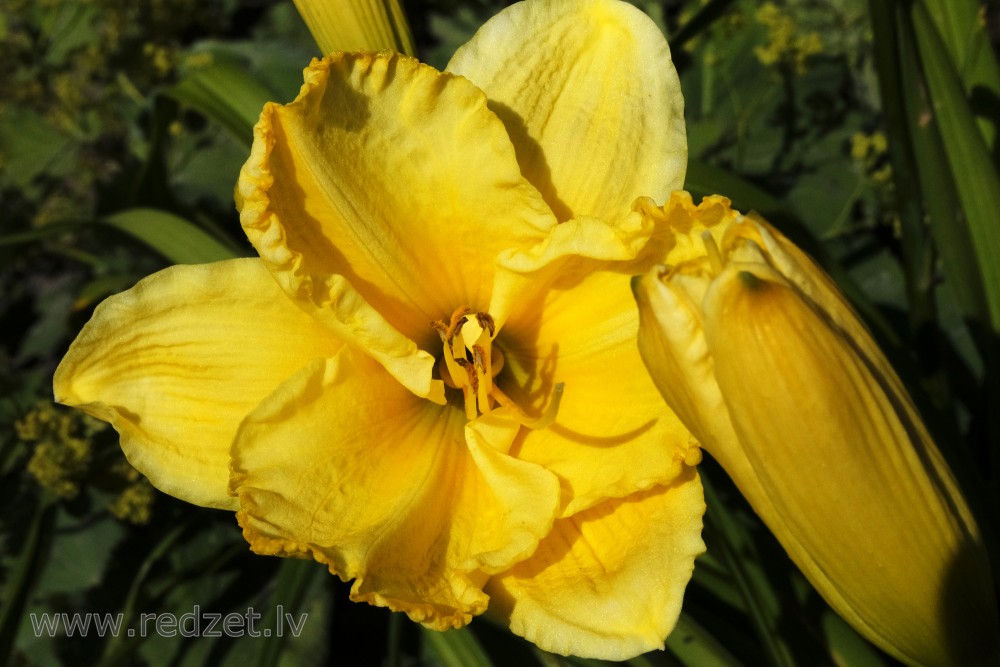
636 192 1000 666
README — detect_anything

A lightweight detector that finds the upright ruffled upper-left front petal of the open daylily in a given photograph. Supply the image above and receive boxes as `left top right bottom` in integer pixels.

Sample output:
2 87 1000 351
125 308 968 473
237 53 555 350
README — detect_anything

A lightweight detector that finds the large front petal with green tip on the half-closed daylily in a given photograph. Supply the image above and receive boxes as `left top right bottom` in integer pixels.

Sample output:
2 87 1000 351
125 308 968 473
705 264 998 665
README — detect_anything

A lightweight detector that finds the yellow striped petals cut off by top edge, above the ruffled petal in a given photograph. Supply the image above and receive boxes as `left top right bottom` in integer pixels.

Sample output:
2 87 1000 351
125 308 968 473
295 0 414 55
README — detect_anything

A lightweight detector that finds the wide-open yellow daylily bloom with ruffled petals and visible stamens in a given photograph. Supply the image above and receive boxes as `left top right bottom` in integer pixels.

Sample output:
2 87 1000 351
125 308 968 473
54 0 704 659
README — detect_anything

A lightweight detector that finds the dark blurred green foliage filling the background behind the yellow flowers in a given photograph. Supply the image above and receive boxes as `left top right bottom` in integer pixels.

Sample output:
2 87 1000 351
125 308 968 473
0 0 1000 667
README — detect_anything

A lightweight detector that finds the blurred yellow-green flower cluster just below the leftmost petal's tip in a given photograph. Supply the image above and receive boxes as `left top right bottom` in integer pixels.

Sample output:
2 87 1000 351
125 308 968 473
15 402 100 498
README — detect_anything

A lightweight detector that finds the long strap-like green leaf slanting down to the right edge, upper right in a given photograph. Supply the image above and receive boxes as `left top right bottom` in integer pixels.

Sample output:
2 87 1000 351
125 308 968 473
911 2 1000 332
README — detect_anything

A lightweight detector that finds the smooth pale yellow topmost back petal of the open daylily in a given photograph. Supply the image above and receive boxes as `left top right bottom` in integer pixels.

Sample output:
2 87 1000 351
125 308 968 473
447 0 687 220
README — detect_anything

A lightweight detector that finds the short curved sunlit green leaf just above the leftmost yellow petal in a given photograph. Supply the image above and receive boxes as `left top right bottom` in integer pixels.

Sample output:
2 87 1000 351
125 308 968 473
103 208 238 264
